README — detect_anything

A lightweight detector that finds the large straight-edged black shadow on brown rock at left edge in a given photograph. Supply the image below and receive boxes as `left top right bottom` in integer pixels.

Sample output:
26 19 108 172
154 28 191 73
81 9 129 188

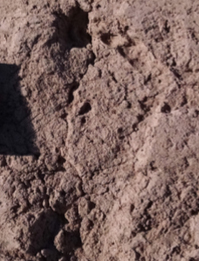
0 64 39 155
